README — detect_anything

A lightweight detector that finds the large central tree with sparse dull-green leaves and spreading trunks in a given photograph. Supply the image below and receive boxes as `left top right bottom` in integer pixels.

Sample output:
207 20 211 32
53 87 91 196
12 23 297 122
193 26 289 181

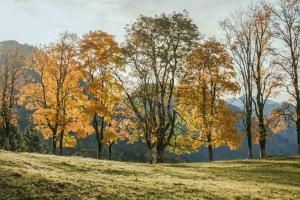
123 12 199 163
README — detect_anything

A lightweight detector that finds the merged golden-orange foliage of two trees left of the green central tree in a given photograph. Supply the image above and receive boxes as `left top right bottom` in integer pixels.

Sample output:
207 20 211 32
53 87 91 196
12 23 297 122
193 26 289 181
18 31 125 152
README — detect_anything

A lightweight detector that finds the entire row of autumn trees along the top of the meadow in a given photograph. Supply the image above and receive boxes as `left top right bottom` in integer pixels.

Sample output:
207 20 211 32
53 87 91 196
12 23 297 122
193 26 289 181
0 0 300 163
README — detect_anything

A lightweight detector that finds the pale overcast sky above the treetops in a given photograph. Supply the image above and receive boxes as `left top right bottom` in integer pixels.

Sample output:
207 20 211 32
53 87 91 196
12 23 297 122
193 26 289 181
0 0 252 45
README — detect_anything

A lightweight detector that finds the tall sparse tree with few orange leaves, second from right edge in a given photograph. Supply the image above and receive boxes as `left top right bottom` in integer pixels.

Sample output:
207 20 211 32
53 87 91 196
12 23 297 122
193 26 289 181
250 2 281 158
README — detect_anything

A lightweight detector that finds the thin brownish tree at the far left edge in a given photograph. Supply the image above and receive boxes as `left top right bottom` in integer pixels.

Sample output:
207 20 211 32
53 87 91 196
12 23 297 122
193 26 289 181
0 48 27 150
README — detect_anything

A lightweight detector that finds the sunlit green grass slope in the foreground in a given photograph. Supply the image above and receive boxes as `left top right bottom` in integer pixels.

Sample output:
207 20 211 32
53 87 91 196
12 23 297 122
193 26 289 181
0 151 300 200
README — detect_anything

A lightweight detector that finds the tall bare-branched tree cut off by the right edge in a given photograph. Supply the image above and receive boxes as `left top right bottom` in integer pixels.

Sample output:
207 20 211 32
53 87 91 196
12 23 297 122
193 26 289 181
273 0 300 155
